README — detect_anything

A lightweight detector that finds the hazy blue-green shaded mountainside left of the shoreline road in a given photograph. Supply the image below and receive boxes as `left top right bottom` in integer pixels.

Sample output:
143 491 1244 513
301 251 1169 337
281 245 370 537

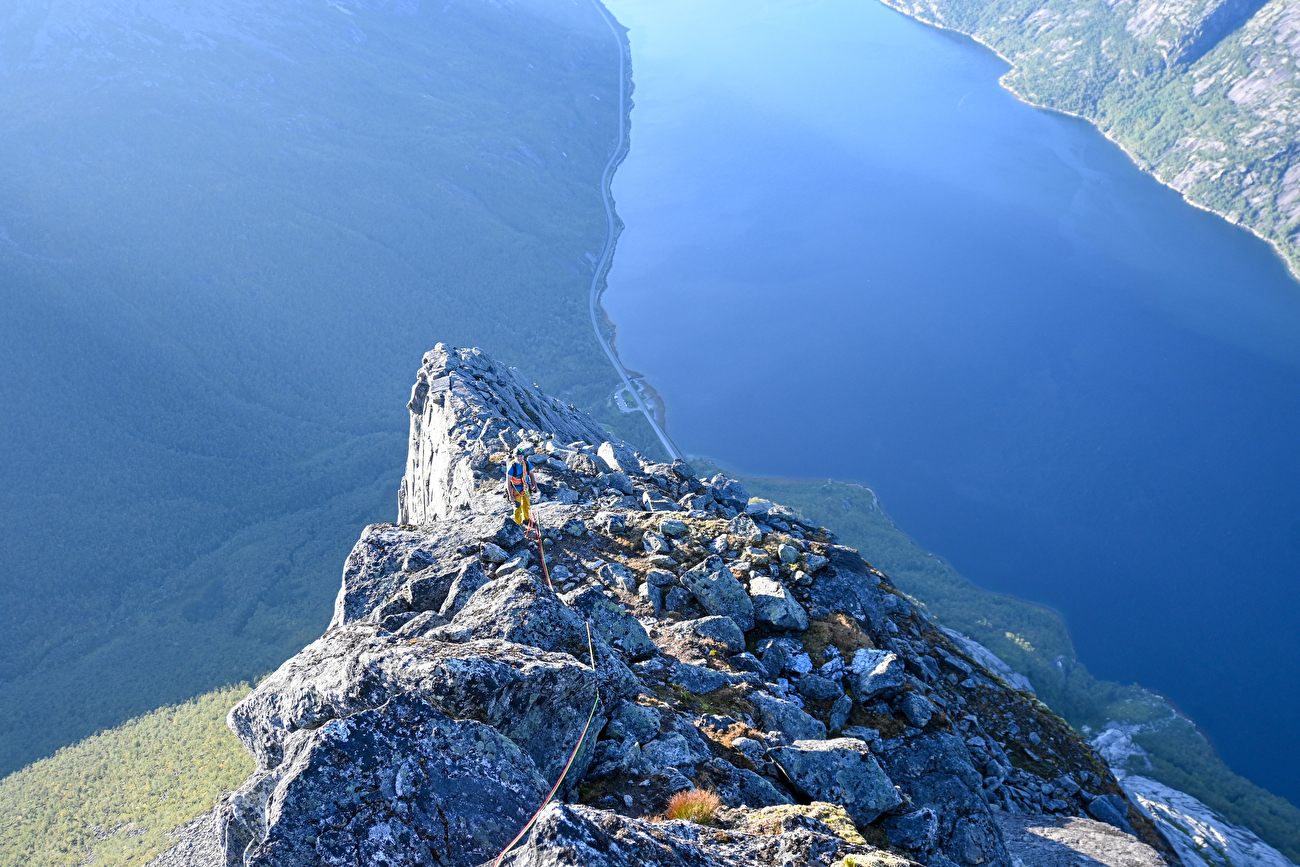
0 0 650 775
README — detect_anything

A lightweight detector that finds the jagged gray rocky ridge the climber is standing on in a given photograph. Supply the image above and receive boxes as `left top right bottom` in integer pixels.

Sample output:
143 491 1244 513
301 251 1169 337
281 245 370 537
157 344 1171 867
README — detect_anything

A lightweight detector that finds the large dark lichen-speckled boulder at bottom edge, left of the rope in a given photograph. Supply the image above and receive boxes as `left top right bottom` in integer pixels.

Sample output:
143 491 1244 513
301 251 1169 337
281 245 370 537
217 697 547 867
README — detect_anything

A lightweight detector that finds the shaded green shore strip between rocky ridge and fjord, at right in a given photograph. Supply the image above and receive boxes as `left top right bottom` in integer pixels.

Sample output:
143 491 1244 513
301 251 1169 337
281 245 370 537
692 459 1300 861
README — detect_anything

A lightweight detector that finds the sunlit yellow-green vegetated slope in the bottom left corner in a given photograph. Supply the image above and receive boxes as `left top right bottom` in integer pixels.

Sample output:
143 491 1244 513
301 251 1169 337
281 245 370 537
0 684 254 867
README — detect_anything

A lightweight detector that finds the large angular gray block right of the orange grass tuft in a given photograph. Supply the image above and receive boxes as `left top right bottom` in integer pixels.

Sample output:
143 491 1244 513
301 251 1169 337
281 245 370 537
768 737 902 827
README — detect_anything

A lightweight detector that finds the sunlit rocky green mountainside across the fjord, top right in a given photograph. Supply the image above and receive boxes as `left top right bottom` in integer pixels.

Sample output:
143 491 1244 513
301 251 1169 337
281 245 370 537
885 0 1300 276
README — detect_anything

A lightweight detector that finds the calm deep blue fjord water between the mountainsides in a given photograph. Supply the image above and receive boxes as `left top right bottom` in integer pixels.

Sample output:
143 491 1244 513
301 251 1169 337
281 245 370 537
605 0 1300 802
